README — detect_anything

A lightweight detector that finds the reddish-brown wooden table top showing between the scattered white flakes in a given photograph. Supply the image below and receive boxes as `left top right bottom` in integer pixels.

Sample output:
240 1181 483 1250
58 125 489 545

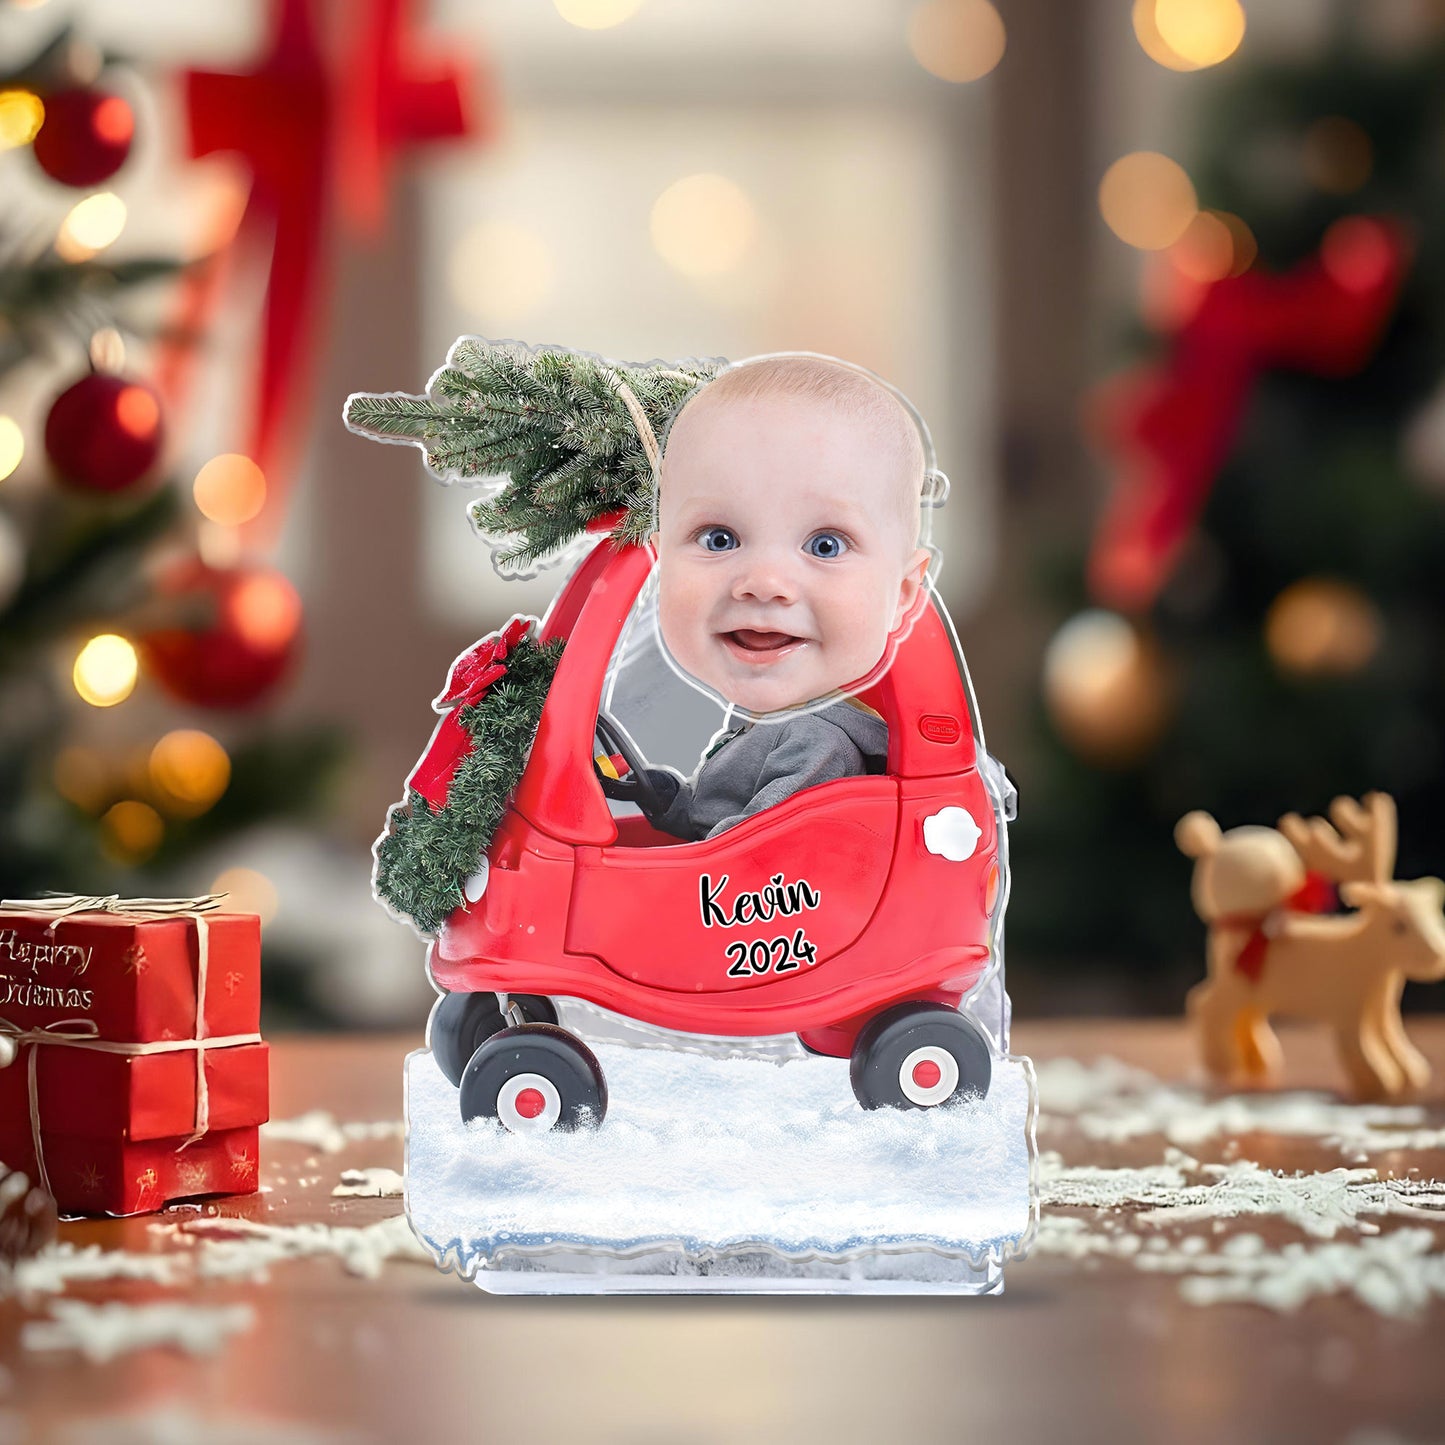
0 1019 1445 1445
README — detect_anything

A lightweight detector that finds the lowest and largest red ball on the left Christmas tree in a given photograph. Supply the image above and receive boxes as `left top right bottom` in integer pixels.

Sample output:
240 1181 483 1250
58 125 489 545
140 559 301 708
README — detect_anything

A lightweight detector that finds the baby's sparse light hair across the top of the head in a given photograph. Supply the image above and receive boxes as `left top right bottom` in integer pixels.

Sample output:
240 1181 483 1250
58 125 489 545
663 355 926 538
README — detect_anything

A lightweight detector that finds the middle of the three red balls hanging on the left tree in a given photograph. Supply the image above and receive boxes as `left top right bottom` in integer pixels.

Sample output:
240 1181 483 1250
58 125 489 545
45 371 162 491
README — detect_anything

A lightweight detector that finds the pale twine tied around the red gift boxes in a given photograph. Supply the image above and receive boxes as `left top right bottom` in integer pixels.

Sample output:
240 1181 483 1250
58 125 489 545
0 893 262 1194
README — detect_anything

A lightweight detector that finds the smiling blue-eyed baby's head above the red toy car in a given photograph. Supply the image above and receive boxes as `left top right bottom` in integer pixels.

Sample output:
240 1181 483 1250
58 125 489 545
652 355 931 720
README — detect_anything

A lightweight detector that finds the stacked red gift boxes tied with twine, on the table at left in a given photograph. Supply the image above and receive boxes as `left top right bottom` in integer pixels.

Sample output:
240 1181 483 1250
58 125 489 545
0 899 267 1214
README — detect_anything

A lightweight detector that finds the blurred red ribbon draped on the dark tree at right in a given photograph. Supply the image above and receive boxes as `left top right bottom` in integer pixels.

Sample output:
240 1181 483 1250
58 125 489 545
1088 217 1409 611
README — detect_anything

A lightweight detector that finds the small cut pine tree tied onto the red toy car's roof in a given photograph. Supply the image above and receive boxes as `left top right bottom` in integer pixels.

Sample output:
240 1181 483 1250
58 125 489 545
345 337 724 565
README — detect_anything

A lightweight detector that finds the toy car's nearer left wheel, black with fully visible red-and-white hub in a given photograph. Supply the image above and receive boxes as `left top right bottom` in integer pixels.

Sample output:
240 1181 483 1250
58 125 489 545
461 1023 607 1134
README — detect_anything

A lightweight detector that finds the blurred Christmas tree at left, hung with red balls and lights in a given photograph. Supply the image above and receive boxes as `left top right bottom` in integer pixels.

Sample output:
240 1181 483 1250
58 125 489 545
0 32 338 897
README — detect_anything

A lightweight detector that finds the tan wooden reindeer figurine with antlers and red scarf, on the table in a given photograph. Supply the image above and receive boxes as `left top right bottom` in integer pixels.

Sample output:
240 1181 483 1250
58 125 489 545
1175 793 1445 1098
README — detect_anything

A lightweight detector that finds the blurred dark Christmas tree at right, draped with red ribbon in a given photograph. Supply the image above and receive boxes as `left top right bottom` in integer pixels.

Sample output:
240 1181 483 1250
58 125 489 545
1010 6 1445 1012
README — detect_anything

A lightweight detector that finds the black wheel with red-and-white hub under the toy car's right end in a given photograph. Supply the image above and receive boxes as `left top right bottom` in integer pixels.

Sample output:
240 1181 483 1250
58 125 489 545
848 1003 993 1108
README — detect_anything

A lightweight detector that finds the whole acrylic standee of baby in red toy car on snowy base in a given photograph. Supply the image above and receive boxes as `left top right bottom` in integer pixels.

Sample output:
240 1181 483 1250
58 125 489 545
345 337 1038 1293
